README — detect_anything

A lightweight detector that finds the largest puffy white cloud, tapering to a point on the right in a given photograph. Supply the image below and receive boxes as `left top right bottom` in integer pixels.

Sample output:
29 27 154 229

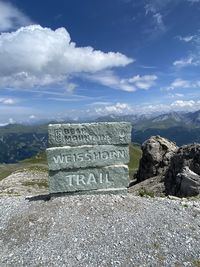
0 25 133 90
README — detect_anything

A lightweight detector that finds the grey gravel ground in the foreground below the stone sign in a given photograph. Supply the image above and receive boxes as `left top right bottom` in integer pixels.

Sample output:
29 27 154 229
0 194 200 267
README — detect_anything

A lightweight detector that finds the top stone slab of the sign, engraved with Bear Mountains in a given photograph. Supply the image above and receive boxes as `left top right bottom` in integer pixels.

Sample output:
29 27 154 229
48 122 132 146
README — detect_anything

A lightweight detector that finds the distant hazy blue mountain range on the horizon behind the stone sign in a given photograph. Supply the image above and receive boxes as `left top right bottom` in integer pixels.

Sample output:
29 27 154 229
0 110 200 163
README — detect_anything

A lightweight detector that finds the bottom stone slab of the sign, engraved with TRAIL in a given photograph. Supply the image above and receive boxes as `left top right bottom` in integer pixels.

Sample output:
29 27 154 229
49 165 129 193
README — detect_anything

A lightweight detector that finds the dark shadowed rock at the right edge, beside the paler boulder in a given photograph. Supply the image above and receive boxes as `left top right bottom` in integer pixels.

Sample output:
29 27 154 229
165 144 200 197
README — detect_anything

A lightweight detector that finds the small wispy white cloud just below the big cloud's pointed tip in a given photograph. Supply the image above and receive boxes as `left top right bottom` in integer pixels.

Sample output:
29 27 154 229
85 71 158 92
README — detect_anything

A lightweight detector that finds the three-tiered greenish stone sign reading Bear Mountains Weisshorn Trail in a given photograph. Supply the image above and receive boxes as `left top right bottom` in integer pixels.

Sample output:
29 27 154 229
46 122 132 194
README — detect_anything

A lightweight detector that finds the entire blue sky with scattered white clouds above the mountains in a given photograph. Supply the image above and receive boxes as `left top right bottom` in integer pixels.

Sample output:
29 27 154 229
0 0 200 124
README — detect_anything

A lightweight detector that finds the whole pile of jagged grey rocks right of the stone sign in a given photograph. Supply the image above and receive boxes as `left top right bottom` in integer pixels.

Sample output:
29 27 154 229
136 136 200 197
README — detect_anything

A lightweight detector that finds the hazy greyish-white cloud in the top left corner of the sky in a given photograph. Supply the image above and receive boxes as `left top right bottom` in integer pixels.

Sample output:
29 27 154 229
0 1 32 31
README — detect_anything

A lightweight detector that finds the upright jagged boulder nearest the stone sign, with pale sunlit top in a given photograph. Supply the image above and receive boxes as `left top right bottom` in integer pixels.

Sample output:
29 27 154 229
136 136 178 182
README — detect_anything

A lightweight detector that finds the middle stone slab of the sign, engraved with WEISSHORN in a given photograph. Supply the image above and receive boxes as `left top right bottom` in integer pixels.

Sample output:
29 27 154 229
46 145 129 170
